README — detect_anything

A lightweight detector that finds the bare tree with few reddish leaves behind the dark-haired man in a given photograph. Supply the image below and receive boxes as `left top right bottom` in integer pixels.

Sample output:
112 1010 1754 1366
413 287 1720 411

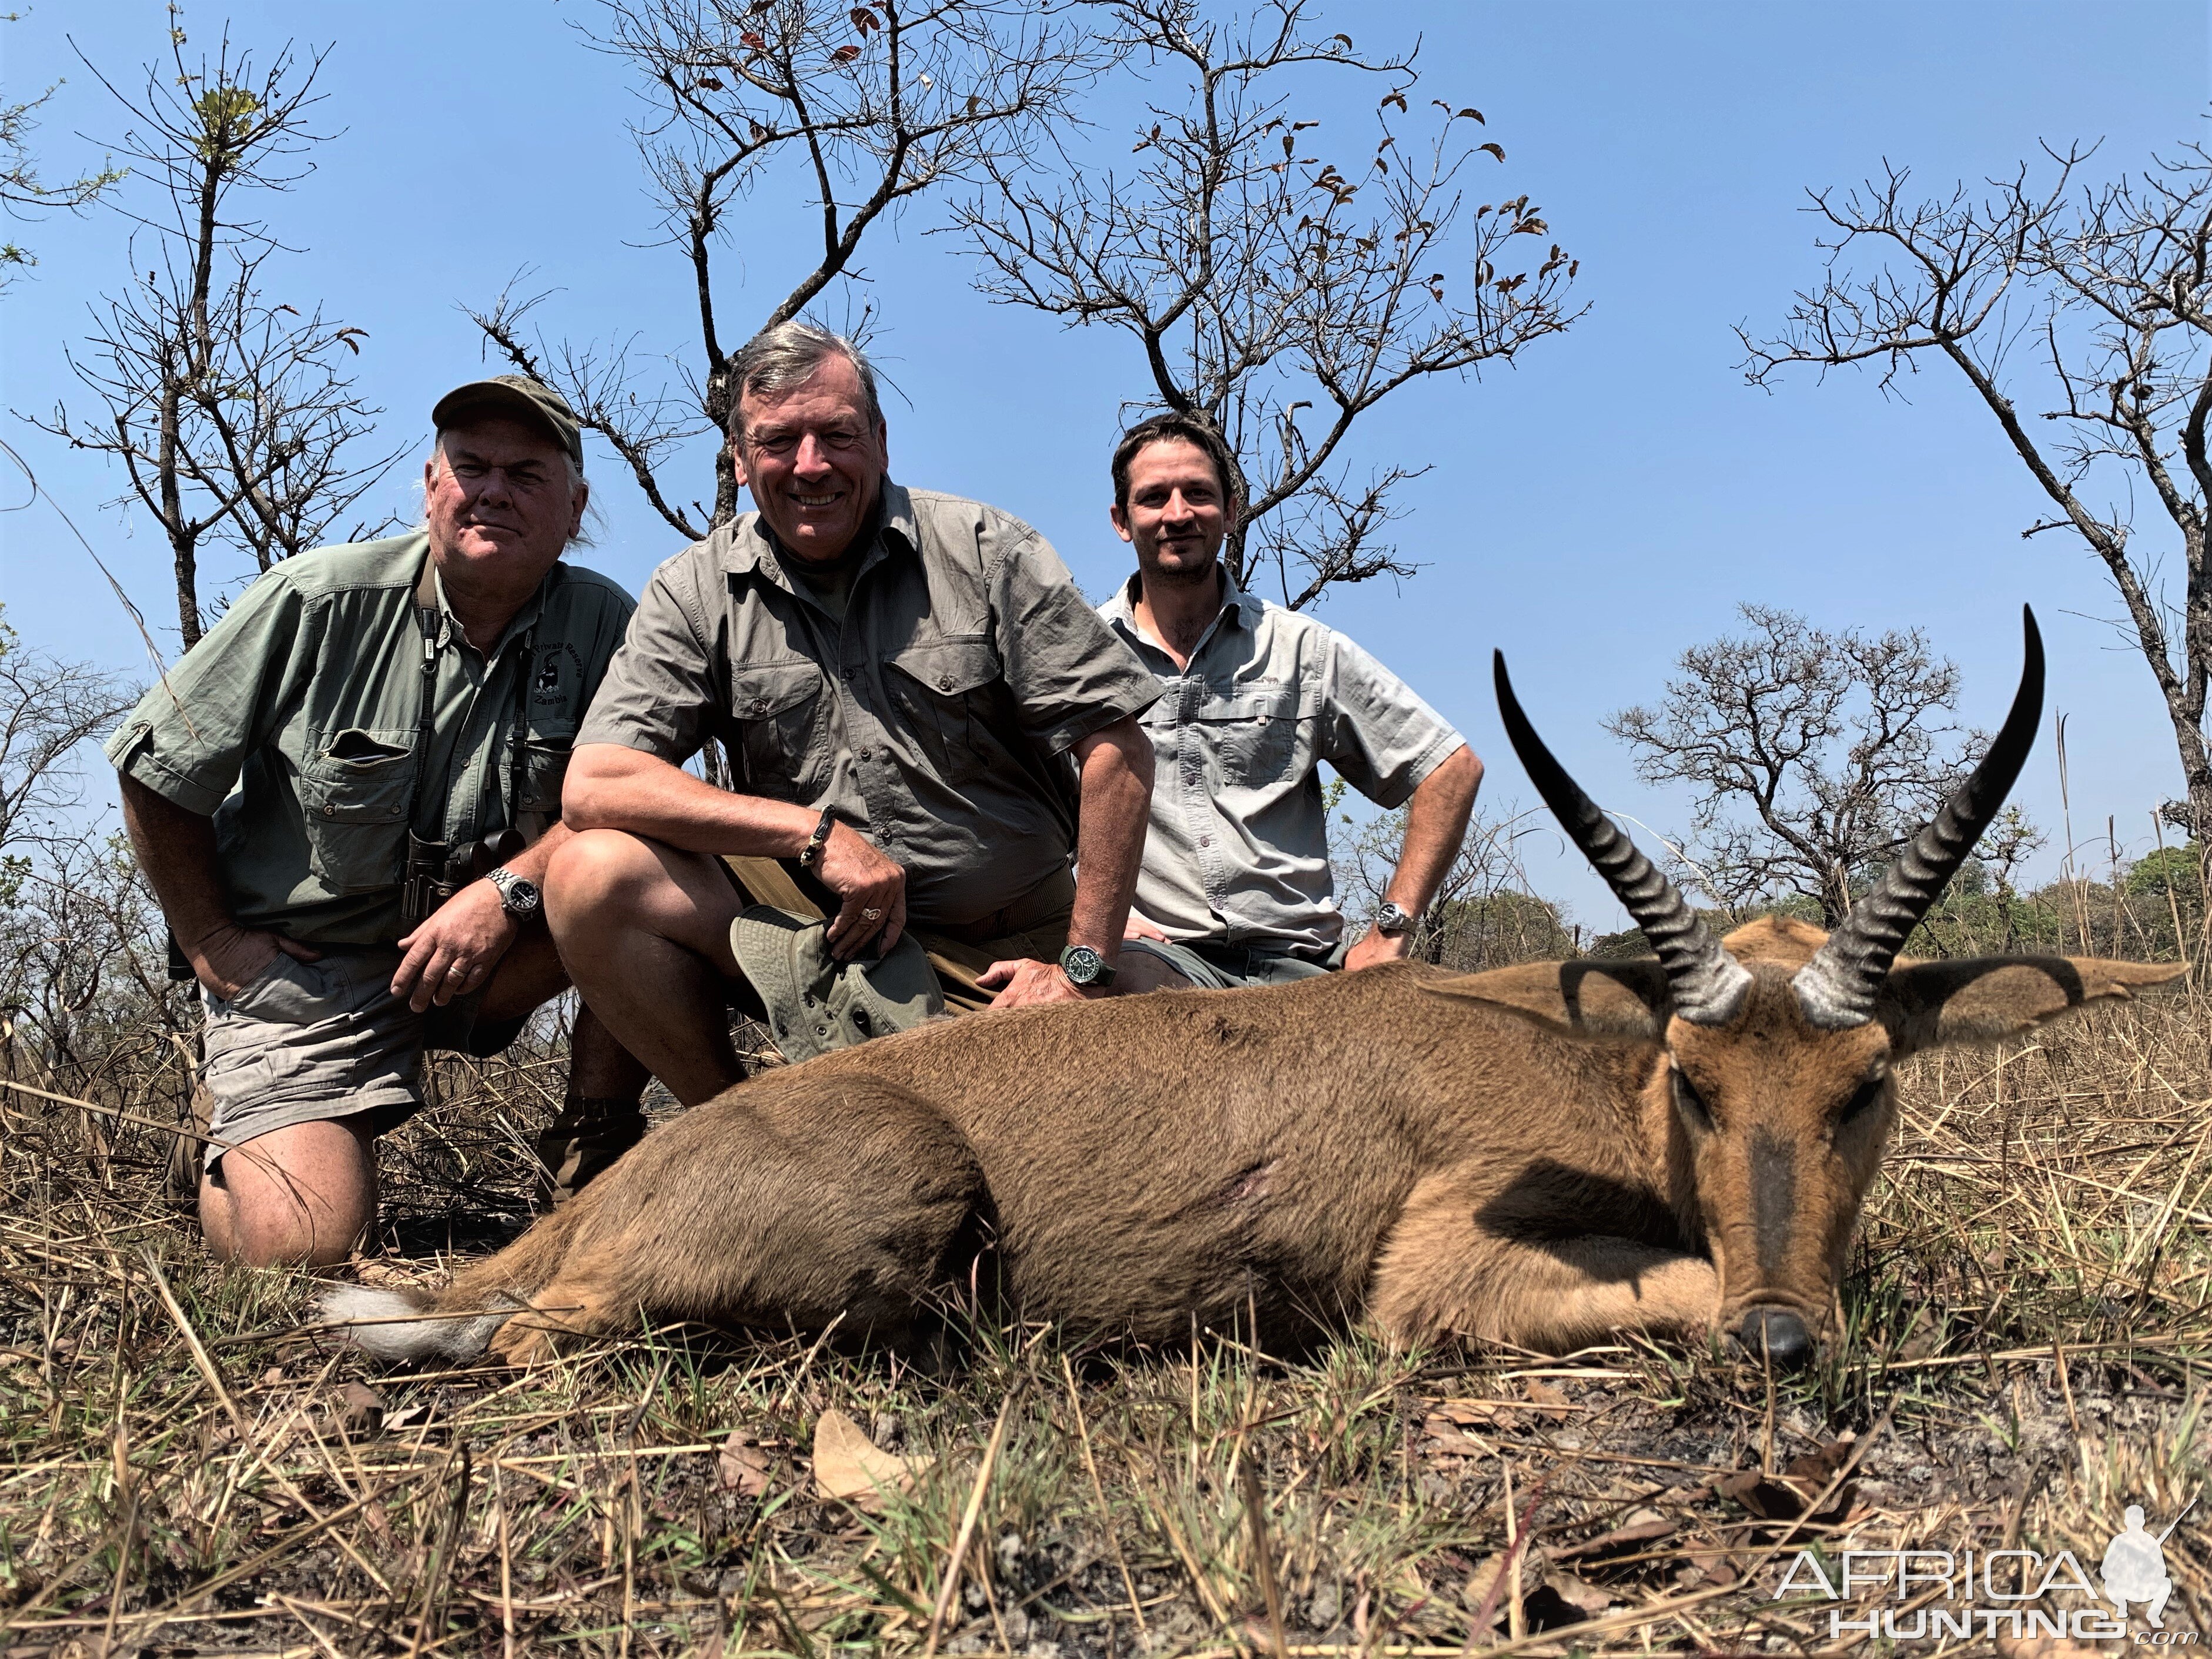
960 0 1579 608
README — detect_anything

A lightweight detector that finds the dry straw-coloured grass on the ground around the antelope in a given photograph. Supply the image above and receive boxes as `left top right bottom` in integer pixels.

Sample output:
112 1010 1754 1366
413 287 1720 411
0 998 2212 1659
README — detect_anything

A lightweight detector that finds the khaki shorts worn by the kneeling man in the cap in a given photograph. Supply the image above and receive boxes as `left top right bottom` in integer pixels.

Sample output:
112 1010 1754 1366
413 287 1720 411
201 946 524 1170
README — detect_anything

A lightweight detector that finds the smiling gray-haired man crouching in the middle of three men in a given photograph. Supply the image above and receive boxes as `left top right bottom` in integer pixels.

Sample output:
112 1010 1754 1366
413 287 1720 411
546 323 1159 1104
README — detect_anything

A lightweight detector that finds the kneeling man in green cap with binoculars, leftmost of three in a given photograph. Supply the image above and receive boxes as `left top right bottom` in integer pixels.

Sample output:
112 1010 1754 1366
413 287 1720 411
108 376 646 1265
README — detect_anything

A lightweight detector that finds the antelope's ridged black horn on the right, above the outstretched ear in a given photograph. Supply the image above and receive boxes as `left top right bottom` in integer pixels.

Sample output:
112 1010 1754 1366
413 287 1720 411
1792 606 2044 1031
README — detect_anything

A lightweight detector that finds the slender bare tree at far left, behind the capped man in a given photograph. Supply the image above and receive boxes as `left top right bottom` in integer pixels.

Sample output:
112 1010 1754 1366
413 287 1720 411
38 29 400 648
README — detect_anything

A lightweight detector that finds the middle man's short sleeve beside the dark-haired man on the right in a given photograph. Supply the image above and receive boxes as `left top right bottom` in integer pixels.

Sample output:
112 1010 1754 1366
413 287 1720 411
991 527 1159 754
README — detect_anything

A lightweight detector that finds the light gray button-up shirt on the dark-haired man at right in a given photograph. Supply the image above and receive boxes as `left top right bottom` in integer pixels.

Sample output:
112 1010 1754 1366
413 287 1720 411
1102 575 1464 955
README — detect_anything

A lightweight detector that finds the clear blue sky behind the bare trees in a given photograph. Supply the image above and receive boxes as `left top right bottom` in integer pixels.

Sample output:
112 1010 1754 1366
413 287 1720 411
0 0 2207 927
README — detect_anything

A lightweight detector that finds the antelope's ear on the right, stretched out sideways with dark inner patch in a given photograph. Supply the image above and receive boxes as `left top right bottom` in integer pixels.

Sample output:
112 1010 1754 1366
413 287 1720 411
1880 955 2188 1055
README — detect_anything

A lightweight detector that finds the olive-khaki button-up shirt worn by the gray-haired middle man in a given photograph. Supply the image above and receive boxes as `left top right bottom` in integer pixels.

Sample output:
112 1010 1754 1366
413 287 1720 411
577 480 1159 927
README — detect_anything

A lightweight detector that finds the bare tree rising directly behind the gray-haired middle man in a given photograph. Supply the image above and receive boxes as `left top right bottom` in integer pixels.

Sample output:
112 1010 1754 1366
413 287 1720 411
471 0 1108 540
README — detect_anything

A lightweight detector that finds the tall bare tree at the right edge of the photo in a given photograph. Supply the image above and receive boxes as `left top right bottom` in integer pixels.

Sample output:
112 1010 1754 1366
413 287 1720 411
1743 144 2212 838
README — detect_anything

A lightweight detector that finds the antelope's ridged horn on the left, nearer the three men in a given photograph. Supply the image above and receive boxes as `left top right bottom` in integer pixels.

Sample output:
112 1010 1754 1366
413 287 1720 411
1493 650 1752 1026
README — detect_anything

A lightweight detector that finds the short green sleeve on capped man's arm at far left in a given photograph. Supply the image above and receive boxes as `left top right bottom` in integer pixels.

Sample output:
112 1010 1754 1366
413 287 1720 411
106 566 314 816
